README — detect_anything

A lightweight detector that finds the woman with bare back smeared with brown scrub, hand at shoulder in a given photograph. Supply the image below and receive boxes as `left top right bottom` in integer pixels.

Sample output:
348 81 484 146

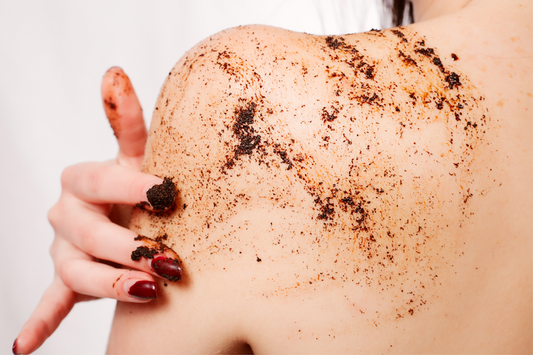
15 0 532 353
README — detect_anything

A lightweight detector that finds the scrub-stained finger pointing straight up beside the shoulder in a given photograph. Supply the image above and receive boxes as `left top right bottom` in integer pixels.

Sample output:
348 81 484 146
102 67 147 168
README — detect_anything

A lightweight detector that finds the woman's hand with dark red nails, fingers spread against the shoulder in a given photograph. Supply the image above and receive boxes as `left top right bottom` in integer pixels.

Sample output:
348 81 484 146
13 67 181 354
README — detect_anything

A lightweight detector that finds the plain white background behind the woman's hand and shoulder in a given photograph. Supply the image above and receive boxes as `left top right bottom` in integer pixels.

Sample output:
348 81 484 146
0 0 382 354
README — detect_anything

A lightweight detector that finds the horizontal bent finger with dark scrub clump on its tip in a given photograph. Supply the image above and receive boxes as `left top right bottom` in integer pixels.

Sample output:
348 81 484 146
61 162 164 207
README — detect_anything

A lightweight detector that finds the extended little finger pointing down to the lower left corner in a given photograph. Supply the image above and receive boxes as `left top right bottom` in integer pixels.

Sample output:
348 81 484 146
13 277 76 354
